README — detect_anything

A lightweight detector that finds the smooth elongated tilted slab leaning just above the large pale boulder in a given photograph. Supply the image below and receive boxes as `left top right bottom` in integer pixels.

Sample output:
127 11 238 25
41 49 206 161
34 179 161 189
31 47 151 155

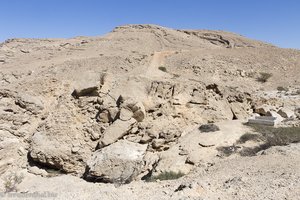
99 118 136 147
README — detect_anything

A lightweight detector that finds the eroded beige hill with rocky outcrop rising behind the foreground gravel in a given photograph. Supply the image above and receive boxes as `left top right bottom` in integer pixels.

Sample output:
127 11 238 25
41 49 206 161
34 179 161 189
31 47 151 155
0 25 300 195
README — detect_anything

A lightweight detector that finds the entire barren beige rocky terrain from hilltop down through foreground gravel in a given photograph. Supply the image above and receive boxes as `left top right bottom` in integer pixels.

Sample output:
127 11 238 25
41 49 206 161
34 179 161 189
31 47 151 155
0 25 300 199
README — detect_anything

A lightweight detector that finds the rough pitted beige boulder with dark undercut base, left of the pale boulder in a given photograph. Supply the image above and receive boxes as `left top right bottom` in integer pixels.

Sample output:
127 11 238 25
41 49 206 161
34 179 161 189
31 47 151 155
28 99 95 174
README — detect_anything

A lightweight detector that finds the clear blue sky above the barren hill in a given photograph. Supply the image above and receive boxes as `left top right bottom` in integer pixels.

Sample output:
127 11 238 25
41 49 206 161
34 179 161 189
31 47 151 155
0 0 300 49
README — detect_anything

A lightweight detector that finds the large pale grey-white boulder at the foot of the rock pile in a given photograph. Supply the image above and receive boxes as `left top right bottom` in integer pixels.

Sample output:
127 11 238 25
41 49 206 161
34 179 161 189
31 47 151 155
86 140 147 183
